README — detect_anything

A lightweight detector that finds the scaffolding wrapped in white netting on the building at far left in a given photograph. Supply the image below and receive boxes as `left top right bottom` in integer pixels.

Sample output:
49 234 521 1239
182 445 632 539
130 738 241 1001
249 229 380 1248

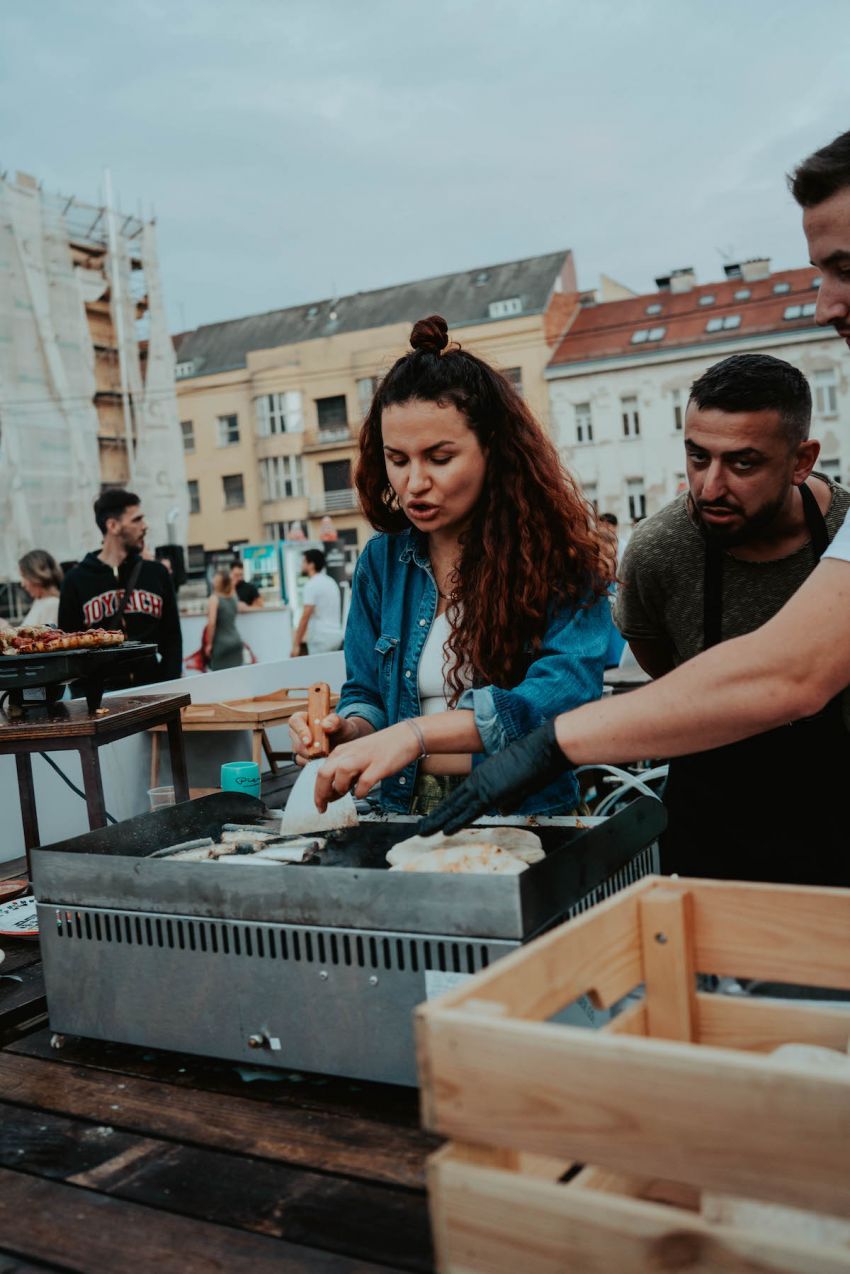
0 173 189 580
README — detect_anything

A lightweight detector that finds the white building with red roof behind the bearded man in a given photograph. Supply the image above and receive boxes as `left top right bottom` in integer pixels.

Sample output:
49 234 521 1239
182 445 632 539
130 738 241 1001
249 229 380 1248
545 260 850 526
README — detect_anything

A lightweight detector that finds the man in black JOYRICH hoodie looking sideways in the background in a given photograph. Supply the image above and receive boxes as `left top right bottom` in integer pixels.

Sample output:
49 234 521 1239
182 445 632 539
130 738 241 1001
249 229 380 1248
59 490 184 689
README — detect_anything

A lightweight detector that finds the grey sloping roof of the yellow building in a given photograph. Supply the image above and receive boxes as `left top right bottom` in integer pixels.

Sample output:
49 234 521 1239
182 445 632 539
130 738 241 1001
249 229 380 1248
175 250 575 376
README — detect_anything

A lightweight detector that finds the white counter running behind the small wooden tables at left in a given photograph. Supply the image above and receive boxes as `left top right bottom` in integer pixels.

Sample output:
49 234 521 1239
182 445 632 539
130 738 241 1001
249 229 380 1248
0 647 345 862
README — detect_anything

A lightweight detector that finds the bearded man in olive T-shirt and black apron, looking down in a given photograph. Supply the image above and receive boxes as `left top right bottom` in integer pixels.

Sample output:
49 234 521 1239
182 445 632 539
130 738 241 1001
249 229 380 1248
617 354 850 880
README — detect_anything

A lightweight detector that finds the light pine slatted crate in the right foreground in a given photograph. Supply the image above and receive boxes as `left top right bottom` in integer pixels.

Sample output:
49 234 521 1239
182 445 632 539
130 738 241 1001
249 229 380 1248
417 877 850 1274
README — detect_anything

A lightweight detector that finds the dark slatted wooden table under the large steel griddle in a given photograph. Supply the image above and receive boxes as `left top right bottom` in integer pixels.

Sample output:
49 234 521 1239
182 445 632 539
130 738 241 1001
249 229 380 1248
0 939 436 1274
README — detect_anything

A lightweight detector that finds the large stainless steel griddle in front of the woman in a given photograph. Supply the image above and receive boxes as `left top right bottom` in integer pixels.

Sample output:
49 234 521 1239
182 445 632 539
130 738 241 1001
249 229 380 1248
33 792 665 1084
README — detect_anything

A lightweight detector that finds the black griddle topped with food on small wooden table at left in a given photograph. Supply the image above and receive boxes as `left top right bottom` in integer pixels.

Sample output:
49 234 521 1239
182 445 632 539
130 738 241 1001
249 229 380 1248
0 641 157 715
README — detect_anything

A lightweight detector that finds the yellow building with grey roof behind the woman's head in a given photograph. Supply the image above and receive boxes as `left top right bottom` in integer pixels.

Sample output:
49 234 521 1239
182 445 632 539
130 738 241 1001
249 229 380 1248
176 251 577 569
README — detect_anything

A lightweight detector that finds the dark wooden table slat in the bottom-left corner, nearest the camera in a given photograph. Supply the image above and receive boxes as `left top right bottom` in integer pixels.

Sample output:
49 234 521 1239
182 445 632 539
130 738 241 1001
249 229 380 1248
0 1168 402 1274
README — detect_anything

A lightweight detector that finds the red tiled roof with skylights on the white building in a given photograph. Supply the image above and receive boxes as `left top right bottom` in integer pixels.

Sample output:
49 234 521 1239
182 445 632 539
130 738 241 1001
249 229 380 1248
549 266 819 369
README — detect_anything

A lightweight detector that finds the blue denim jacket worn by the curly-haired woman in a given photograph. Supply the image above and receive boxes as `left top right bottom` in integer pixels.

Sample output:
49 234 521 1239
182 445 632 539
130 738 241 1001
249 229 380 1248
336 529 610 814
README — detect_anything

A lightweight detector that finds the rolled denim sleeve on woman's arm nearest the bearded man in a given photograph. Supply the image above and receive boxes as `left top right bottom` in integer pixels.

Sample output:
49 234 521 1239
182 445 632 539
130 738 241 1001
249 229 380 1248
457 598 610 764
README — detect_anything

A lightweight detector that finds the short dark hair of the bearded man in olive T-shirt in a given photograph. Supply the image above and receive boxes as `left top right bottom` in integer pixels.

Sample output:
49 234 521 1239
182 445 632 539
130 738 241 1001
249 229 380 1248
688 354 812 447
